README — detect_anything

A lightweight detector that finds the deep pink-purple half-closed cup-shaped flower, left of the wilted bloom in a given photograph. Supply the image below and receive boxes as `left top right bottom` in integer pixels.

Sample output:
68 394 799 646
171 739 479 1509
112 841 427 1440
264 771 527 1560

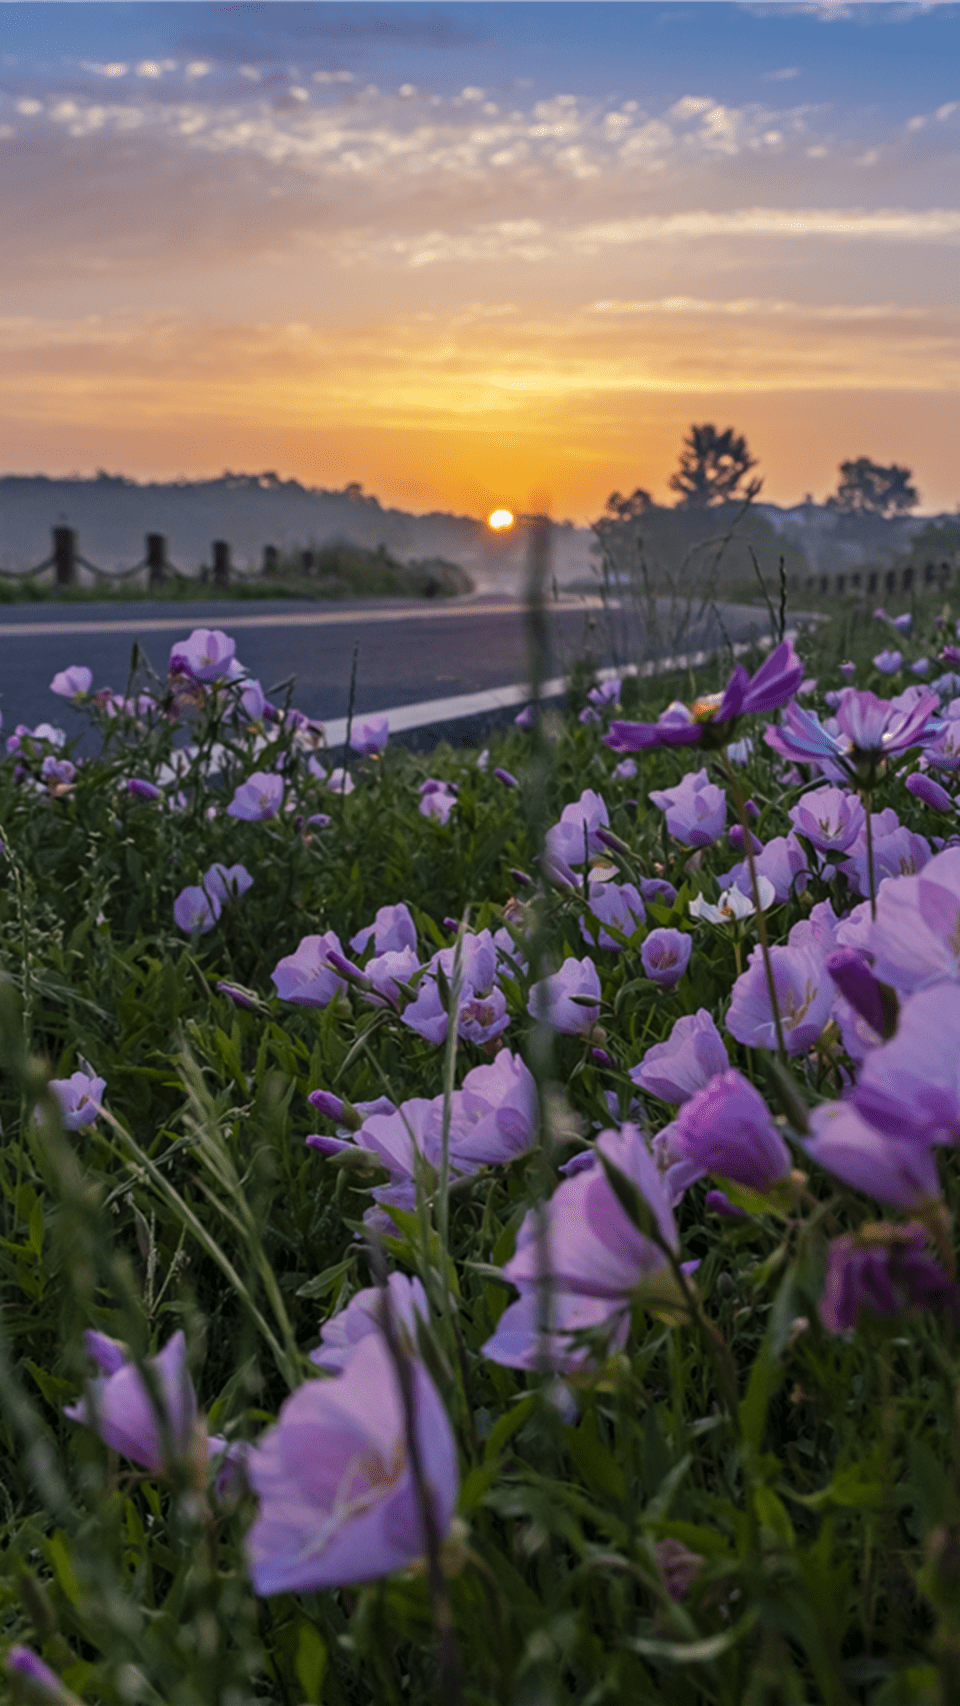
677 1070 789 1192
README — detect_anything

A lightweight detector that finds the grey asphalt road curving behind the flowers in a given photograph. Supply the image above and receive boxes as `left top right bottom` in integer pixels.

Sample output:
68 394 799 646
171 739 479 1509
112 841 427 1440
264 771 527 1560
0 595 777 734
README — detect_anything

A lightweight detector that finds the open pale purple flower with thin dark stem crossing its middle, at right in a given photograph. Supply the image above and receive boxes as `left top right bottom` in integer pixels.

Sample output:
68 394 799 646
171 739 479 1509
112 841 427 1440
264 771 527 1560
726 945 834 1054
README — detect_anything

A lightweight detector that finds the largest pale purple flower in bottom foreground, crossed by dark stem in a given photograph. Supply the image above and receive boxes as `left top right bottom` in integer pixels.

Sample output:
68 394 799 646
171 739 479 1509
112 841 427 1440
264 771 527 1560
246 1332 459 1595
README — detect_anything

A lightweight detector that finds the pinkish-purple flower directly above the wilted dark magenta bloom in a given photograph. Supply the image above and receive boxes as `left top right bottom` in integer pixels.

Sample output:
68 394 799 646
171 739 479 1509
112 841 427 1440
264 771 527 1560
803 1100 940 1211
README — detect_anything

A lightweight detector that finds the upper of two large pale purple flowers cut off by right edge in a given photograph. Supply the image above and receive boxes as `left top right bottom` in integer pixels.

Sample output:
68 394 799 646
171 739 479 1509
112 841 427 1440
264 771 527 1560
868 848 960 995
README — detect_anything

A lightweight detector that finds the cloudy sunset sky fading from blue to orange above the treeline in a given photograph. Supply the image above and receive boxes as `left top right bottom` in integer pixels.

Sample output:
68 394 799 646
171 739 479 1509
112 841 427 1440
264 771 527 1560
0 0 960 522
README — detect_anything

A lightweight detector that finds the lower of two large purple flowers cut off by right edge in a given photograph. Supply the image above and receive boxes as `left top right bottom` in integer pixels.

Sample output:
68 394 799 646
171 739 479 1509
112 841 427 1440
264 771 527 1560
853 983 960 1145
